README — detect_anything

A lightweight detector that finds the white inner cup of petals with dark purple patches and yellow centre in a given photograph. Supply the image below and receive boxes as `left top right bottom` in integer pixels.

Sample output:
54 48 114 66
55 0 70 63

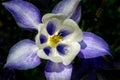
36 14 83 65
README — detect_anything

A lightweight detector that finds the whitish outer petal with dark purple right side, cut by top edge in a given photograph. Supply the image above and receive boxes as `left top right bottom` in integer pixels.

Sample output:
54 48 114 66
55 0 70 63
52 0 81 23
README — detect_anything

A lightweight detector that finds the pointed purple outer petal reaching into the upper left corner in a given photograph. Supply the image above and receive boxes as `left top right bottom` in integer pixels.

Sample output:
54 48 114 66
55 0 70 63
3 0 41 30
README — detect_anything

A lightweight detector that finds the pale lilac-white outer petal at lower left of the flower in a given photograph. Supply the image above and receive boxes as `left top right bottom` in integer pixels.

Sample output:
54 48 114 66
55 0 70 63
4 39 41 70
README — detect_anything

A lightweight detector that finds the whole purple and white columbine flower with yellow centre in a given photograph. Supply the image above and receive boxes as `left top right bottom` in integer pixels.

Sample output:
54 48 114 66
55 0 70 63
3 0 110 80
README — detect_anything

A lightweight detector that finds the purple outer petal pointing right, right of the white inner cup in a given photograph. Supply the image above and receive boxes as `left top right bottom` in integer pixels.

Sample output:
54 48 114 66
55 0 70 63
78 32 111 58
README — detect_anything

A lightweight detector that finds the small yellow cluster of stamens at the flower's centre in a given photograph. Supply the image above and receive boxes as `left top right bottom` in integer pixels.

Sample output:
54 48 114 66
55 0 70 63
49 35 62 47
